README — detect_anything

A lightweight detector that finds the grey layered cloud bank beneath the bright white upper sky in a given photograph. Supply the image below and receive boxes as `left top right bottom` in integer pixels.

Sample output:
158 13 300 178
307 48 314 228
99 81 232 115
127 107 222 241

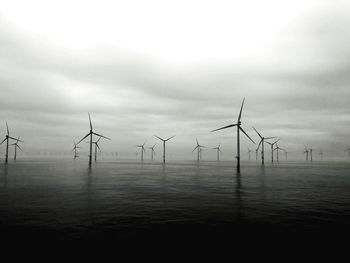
0 1 350 161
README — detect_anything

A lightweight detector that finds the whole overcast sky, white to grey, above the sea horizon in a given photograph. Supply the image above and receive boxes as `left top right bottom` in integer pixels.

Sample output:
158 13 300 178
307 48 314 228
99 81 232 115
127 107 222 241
0 0 350 160
